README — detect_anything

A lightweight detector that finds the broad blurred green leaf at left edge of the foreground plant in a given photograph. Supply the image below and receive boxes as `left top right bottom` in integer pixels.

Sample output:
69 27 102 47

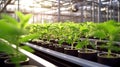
0 20 22 43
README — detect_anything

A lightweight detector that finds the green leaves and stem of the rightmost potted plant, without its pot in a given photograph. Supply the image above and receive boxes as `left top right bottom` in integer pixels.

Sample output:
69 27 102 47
94 20 120 57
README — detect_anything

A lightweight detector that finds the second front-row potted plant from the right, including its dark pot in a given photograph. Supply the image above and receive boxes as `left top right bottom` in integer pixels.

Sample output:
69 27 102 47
76 22 97 61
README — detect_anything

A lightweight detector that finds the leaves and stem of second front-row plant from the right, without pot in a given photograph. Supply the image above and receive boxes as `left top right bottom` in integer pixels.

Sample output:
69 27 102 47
75 22 95 52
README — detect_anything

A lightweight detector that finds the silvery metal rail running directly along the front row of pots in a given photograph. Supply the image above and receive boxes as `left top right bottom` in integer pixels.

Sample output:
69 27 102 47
24 43 109 67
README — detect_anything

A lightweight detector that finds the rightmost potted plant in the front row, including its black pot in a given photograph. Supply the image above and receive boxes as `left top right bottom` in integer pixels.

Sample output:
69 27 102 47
94 20 120 67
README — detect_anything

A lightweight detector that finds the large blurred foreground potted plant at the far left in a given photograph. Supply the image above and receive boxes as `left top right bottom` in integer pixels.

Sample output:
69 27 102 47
0 11 39 67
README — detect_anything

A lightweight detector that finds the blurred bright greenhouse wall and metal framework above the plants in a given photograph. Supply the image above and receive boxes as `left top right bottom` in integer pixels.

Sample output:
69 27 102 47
0 0 120 22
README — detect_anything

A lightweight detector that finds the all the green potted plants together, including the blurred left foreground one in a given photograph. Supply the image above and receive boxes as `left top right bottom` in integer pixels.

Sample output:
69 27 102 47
0 11 120 67
